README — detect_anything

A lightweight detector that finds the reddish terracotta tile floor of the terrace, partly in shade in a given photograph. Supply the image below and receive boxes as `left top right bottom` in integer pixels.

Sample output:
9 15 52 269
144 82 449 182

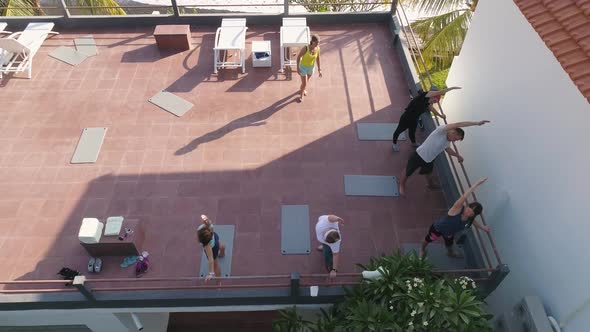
0 25 444 288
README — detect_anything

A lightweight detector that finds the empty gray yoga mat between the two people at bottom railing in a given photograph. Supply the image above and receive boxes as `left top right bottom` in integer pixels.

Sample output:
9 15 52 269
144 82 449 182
281 205 311 255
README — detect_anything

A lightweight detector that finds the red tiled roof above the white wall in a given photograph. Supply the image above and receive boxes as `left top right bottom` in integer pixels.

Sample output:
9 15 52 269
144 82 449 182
514 0 590 102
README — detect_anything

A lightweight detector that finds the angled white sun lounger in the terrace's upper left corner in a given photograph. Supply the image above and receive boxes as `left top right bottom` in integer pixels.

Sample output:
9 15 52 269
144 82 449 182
0 22 58 78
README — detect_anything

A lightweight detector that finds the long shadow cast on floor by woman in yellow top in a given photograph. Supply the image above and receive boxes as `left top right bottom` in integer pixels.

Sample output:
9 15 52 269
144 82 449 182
174 92 297 156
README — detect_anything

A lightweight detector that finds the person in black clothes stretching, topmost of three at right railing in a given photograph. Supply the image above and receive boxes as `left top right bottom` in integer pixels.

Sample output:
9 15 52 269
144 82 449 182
393 87 461 152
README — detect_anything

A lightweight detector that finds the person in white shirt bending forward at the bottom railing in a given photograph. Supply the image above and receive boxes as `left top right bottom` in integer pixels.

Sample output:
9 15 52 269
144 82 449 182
315 215 344 278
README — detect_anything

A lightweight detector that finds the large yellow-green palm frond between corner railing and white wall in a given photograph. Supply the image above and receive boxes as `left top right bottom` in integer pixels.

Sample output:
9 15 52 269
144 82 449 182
412 10 473 69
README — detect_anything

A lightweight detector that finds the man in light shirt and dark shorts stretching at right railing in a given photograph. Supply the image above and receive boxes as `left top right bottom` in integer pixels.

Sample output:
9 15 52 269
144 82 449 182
399 120 489 196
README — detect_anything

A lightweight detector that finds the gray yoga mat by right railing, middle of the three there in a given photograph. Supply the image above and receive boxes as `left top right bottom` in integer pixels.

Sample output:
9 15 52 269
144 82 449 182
344 175 399 197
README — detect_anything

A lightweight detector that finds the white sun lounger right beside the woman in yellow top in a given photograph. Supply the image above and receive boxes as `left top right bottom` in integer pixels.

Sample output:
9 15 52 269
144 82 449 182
280 17 311 72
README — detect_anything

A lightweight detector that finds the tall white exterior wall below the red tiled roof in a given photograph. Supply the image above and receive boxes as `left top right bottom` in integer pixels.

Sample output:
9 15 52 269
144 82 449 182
443 0 590 331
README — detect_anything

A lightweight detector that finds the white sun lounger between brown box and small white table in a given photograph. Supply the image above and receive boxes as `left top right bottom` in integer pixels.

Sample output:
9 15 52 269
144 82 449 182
213 18 248 74
